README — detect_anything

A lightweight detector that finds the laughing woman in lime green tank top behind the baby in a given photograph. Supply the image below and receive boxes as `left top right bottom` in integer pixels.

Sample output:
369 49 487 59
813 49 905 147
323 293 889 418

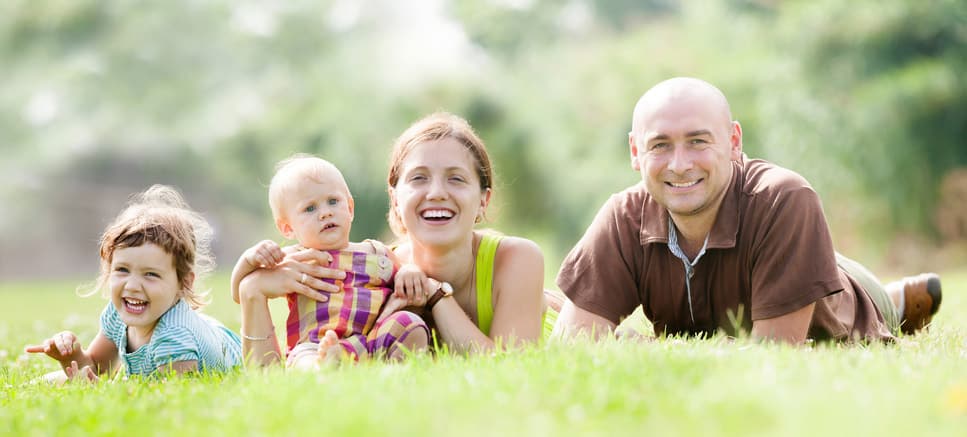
387 113 544 351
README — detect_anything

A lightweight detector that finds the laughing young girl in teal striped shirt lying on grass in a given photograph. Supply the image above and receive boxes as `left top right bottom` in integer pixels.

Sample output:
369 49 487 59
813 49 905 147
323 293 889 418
26 185 241 381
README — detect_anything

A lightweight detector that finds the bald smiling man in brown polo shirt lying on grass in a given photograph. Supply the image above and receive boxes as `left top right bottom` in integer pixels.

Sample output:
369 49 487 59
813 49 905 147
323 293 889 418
555 78 941 344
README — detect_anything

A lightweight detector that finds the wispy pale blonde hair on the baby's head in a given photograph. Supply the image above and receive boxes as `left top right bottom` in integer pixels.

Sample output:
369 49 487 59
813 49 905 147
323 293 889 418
269 153 352 220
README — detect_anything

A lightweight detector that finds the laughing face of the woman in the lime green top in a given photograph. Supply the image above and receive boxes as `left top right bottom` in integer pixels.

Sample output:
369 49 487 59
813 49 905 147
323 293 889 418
390 138 490 245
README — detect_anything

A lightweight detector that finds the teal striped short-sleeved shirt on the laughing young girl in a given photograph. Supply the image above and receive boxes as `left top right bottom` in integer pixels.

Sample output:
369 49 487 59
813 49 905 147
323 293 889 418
101 300 242 376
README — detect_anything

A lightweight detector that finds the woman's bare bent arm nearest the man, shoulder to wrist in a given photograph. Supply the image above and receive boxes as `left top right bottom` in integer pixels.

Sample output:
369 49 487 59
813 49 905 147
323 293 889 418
432 237 544 352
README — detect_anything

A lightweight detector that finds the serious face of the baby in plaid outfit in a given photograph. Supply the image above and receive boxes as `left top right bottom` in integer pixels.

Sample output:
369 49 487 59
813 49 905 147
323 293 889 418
280 173 353 250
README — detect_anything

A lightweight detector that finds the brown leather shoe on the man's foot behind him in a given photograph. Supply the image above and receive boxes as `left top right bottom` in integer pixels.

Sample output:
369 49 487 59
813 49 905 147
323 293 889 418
885 273 942 334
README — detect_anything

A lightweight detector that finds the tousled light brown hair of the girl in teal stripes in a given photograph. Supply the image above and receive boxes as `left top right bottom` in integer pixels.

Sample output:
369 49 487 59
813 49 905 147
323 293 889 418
86 185 215 309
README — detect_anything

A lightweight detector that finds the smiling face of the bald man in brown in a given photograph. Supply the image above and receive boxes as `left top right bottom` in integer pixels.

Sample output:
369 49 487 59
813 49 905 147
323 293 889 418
629 93 742 218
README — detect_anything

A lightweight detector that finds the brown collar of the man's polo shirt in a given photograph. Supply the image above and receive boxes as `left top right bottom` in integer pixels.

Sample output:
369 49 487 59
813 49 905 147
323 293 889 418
639 154 746 249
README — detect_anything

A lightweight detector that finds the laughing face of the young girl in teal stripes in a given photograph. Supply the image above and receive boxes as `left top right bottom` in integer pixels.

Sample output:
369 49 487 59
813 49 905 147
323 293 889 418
108 243 181 329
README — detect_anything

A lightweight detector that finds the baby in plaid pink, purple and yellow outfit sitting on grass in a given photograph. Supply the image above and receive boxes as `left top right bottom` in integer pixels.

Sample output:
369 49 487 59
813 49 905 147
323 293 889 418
232 154 429 368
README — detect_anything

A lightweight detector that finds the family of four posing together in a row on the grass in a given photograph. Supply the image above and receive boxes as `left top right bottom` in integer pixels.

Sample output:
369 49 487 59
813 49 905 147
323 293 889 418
26 78 941 381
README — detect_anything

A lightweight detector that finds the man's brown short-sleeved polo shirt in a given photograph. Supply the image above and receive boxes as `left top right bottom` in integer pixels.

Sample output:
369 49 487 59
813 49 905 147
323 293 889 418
557 156 893 340
